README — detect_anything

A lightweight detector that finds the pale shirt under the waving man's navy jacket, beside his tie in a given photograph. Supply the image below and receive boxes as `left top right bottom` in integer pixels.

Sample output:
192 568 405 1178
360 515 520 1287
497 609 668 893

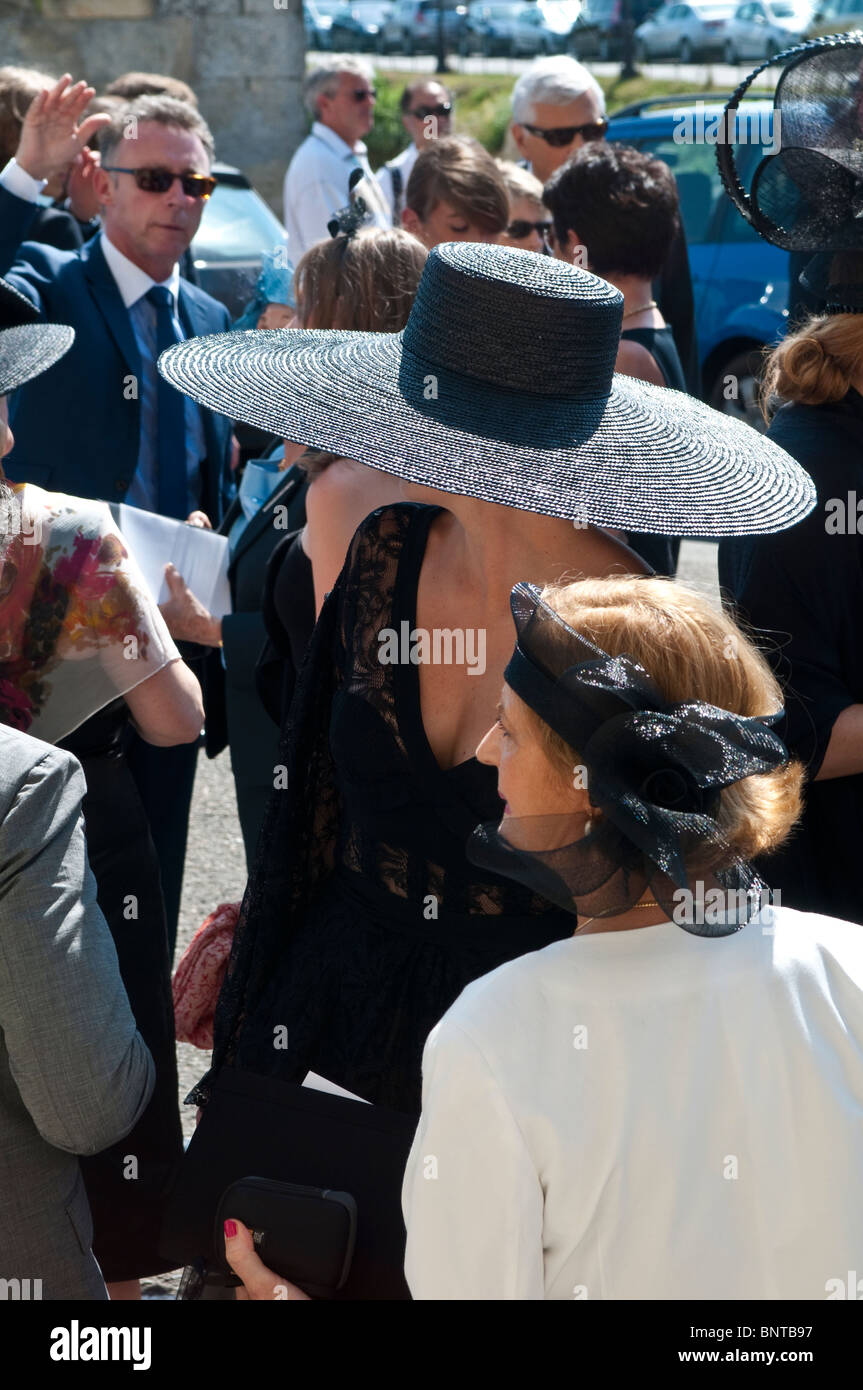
101 232 207 514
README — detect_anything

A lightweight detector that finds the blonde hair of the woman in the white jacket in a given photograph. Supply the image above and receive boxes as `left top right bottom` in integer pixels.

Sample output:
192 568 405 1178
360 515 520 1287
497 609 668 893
511 574 803 860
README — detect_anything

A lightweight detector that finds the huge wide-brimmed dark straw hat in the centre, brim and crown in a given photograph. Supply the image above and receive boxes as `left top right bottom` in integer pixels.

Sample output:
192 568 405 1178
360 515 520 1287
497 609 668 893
158 242 816 535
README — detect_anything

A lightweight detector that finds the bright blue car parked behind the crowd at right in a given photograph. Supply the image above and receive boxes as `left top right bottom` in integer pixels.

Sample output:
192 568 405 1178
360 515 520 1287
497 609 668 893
609 95 788 430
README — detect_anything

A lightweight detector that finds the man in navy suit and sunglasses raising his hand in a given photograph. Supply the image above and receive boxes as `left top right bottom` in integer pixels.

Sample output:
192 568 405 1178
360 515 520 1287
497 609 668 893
0 75 235 934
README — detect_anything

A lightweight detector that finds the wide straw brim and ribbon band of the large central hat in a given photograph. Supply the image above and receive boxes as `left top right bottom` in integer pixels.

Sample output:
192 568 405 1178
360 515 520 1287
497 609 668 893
158 329 816 537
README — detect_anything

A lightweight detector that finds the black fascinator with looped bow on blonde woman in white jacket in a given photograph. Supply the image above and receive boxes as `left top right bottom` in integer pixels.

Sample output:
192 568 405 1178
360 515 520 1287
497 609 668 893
467 584 788 935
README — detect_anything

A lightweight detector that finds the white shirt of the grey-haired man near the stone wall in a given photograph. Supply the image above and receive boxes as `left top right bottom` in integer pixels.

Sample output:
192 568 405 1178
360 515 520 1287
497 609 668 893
285 121 392 265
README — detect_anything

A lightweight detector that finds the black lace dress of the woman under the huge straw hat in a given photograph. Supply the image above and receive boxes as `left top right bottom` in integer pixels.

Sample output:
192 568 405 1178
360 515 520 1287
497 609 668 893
190 503 573 1113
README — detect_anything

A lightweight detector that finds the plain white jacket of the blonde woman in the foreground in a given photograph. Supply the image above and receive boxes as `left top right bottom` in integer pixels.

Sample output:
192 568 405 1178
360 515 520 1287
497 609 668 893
402 908 863 1300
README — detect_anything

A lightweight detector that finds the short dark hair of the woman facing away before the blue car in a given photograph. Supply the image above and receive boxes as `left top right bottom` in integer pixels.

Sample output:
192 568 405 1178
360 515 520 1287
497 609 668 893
542 140 680 279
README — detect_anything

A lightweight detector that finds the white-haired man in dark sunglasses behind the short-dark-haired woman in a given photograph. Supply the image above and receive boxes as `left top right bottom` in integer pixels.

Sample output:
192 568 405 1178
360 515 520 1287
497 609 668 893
510 54 700 396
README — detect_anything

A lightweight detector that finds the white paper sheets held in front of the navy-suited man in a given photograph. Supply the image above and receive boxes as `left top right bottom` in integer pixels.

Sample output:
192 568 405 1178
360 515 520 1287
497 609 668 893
111 502 231 617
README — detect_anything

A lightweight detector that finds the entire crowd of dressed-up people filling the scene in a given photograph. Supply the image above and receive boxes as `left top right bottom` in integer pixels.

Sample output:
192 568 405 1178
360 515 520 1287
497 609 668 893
0 36 863 1300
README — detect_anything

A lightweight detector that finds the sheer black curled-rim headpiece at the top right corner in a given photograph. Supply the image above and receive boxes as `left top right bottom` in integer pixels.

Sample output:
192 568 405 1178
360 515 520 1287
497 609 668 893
716 33 863 313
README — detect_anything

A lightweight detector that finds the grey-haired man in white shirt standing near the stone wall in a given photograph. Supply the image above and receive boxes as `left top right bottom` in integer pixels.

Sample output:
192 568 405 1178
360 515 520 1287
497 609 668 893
285 53 392 255
